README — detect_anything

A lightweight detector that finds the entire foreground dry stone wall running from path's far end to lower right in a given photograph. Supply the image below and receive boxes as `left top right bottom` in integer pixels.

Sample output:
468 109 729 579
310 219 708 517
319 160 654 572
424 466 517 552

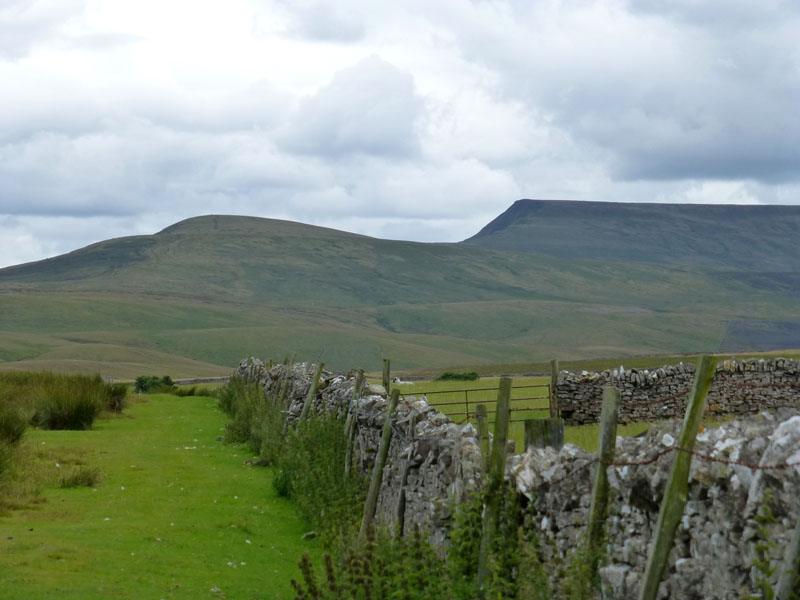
231 359 800 600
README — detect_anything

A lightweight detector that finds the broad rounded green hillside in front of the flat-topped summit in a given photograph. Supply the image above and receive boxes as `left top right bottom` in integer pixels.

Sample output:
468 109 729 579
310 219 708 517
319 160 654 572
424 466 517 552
0 203 800 377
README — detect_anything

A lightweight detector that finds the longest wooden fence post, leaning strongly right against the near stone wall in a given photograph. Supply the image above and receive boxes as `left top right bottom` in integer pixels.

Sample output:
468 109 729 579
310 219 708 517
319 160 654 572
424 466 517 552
639 356 717 600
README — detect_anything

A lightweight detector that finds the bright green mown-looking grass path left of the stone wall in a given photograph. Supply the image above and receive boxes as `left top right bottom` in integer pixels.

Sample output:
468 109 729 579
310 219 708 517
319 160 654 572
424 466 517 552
0 395 321 600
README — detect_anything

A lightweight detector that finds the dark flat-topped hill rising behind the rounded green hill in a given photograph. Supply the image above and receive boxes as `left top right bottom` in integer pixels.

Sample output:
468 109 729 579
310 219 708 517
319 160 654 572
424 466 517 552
464 200 800 273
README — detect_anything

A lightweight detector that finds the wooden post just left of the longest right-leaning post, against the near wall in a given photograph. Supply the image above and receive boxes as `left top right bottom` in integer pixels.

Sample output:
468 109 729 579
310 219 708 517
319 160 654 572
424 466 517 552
587 386 619 577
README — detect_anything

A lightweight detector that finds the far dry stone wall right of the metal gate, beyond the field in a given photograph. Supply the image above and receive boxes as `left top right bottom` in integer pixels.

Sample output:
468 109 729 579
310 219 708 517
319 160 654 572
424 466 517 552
558 358 800 424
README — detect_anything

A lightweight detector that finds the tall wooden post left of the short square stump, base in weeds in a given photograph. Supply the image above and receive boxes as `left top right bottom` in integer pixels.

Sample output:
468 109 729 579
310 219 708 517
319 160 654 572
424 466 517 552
478 377 511 597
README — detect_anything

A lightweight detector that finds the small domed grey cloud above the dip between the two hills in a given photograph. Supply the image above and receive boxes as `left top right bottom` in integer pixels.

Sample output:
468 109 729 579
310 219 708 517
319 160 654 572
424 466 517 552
280 56 421 159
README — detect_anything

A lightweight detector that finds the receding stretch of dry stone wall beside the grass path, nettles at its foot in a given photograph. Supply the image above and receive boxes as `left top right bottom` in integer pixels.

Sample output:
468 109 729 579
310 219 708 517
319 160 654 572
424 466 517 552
231 359 481 547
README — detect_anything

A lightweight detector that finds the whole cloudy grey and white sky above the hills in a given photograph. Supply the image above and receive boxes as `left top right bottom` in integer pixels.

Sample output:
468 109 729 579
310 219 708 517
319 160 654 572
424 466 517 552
0 0 800 267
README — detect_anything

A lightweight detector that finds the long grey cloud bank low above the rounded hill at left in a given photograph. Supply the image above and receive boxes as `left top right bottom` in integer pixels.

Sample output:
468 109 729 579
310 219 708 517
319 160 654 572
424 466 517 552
0 119 331 216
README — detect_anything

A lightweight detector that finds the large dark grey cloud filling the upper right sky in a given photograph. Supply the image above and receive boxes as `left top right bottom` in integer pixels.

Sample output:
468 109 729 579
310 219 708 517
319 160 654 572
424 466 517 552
446 1 800 182
